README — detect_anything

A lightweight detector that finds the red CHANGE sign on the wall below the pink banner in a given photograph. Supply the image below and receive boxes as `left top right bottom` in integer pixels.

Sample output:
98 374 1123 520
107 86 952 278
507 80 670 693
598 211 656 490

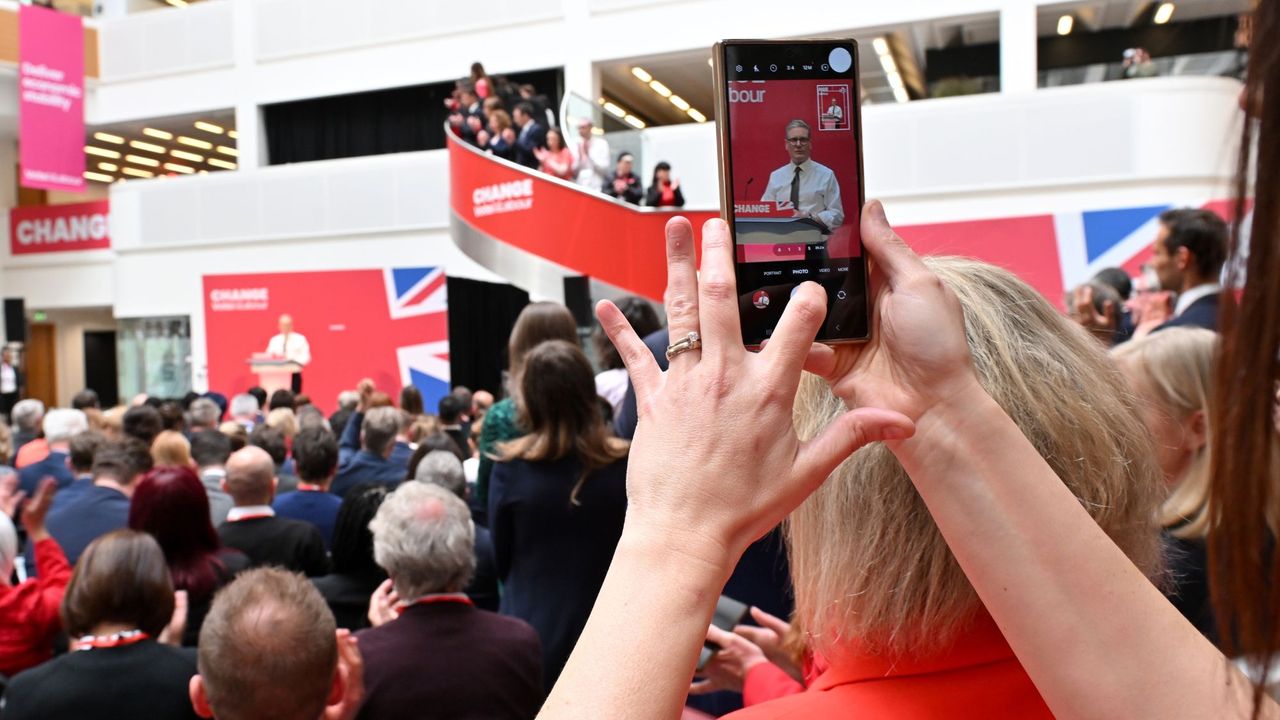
9 200 111 255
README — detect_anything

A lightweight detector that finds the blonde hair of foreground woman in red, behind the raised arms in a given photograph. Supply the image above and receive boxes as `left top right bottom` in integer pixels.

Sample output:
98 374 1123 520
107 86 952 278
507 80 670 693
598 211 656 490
786 258 1161 660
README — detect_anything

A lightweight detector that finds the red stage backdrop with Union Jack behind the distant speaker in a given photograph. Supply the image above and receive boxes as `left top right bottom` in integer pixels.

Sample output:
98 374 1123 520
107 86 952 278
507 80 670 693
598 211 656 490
204 268 451 413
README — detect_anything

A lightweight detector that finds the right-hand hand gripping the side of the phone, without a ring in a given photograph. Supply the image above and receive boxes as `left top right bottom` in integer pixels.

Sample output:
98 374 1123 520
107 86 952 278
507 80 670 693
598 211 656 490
805 200 980 421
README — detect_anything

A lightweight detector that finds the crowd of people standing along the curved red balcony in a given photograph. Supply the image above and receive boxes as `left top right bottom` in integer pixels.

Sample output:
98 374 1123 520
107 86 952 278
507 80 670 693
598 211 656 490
445 63 685 208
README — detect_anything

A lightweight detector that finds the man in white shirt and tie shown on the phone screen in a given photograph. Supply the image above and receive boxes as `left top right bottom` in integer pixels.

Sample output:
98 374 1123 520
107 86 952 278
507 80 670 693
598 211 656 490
760 119 845 229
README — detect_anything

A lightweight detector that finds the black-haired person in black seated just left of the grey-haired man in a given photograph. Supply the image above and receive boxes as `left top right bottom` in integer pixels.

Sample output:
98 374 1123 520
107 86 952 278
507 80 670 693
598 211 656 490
312 484 388 630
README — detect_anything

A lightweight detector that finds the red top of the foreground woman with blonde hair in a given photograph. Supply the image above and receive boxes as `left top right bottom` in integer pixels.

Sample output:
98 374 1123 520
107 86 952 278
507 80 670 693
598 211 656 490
728 612 1053 720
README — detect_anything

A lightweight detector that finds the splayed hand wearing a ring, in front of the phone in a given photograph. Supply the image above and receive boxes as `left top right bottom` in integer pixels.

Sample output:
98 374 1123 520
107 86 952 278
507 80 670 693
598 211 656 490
596 218 914 563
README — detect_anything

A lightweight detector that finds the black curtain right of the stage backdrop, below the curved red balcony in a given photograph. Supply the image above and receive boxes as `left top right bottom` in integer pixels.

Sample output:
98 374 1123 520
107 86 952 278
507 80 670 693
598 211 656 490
447 278 529 397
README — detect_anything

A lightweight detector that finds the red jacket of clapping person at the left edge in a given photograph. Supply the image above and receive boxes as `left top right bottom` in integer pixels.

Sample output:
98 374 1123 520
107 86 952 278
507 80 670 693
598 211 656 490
0 538 72 676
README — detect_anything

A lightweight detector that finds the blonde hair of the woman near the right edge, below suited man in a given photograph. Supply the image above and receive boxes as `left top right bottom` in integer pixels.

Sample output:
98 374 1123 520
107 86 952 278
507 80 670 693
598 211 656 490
1111 328 1217 539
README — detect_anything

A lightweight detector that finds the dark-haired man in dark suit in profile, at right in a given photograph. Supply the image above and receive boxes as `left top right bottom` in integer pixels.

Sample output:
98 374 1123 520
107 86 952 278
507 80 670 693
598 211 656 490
1151 208 1229 332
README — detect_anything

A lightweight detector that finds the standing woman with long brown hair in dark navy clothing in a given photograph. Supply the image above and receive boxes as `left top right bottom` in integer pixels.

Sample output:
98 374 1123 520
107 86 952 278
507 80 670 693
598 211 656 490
489 341 628 691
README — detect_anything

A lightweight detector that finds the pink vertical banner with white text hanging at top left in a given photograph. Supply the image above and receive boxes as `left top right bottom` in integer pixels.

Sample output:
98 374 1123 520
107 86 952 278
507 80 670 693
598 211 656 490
18 5 84 192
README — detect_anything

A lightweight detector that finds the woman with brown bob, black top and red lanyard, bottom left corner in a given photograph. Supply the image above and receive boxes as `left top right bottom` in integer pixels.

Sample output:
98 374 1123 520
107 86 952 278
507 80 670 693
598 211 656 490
4 530 196 720
